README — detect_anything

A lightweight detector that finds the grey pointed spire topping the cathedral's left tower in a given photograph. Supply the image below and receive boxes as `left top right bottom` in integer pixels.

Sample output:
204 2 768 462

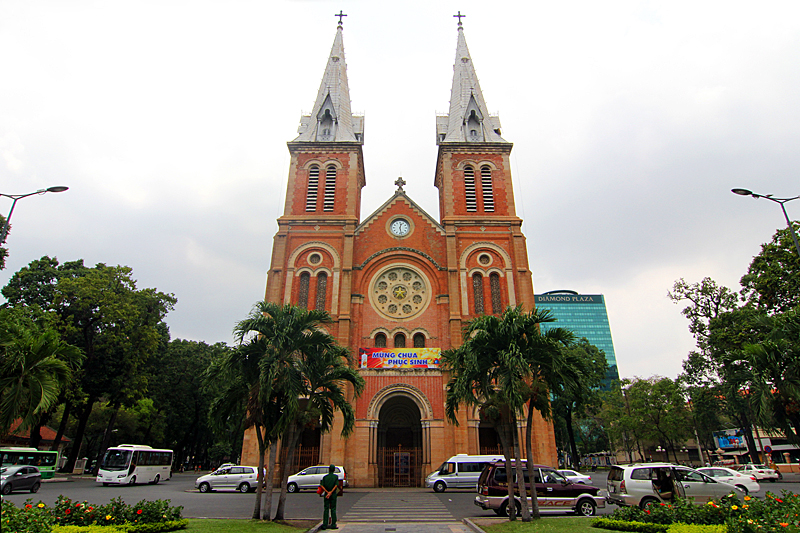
294 17 364 143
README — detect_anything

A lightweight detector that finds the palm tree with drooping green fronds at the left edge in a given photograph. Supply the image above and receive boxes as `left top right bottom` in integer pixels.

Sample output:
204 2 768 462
0 310 83 435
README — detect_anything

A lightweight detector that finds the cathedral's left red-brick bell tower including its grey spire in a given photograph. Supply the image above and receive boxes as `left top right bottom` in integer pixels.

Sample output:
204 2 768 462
266 15 366 345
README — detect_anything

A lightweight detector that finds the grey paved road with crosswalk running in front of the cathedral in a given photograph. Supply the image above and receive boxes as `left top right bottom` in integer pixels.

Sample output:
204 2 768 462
7 472 800 520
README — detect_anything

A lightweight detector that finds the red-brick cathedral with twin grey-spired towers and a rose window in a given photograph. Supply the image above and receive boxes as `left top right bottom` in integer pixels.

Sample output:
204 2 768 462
242 17 557 487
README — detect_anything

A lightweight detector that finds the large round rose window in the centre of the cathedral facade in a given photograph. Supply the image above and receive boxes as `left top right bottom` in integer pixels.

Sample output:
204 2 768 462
370 266 430 319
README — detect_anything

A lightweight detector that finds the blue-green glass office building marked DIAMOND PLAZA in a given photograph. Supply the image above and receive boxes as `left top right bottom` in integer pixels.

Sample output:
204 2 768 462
534 290 619 389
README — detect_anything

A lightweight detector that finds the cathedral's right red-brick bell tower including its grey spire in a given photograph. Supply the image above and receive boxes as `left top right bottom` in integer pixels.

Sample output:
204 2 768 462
434 13 534 345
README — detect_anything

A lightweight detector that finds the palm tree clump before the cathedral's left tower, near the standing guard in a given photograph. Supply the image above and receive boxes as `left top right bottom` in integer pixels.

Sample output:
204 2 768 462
234 302 364 520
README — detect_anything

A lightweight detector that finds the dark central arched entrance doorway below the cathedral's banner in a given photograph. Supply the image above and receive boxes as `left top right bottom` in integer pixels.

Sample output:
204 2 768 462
378 394 424 487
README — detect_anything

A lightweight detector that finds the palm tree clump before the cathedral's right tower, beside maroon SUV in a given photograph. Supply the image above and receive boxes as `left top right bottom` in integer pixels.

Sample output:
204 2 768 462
442 307 571 521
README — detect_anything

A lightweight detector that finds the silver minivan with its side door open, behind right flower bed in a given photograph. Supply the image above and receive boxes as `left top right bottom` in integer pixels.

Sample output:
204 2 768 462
607 463 740 509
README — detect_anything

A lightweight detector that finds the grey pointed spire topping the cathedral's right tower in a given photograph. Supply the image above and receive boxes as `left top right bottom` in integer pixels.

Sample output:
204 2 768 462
436 16 507 143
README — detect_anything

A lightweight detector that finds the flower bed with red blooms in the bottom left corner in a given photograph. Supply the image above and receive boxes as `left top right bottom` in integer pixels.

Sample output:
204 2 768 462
0 496 188 533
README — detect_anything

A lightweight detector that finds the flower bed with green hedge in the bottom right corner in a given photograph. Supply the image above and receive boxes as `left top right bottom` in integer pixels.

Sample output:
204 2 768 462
594 491 800 533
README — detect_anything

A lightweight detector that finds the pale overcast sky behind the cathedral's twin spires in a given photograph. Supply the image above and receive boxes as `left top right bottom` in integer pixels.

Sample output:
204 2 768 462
0 0 800 377
